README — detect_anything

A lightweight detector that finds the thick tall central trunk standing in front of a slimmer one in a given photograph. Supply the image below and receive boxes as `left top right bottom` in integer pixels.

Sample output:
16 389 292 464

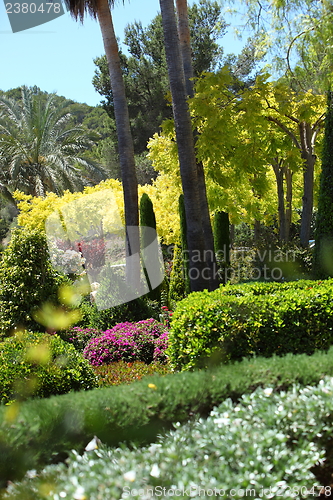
160 0 210 291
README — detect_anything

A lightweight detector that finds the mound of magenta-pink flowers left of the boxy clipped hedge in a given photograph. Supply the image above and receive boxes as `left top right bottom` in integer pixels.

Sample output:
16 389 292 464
83 319 168 366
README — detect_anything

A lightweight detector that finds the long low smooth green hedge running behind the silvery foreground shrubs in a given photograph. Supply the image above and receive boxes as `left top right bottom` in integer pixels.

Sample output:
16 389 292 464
0 349 333 486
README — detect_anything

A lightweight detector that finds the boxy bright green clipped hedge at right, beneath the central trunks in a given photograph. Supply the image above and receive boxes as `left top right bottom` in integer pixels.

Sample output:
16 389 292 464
167 280 333 370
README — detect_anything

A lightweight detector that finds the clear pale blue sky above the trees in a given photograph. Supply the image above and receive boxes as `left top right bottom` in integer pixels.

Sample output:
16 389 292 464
0 0 241 106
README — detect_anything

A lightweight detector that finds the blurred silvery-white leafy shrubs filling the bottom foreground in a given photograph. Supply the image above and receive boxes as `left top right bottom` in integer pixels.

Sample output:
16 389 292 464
4 378 333 500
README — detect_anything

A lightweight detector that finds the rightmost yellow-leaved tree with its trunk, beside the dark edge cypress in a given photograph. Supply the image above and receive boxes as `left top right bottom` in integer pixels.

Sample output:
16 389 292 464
237 75 326 246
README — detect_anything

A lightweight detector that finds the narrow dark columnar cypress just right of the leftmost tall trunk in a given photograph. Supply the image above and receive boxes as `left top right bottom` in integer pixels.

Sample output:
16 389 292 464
140 193 161 302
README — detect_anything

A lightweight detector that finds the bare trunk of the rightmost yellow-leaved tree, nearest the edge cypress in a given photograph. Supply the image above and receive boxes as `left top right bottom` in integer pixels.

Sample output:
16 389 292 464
299 122 316 247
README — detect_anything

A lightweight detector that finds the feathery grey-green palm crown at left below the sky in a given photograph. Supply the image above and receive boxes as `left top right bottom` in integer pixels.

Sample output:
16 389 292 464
0 87 105 197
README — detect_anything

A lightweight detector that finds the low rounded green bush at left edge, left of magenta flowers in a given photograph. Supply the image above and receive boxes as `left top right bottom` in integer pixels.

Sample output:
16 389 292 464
0 332 98 403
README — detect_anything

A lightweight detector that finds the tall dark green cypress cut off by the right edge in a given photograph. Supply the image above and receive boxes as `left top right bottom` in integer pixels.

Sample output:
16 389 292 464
314 91 333 278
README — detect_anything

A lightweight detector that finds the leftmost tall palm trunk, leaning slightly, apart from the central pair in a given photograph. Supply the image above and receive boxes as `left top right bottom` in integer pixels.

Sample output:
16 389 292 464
96 0 140 290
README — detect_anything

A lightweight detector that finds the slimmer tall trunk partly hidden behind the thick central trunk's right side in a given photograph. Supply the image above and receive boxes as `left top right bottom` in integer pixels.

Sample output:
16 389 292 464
176 0 220 290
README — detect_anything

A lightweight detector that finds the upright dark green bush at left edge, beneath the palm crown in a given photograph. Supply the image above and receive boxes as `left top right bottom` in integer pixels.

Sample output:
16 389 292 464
0 229 68 337
